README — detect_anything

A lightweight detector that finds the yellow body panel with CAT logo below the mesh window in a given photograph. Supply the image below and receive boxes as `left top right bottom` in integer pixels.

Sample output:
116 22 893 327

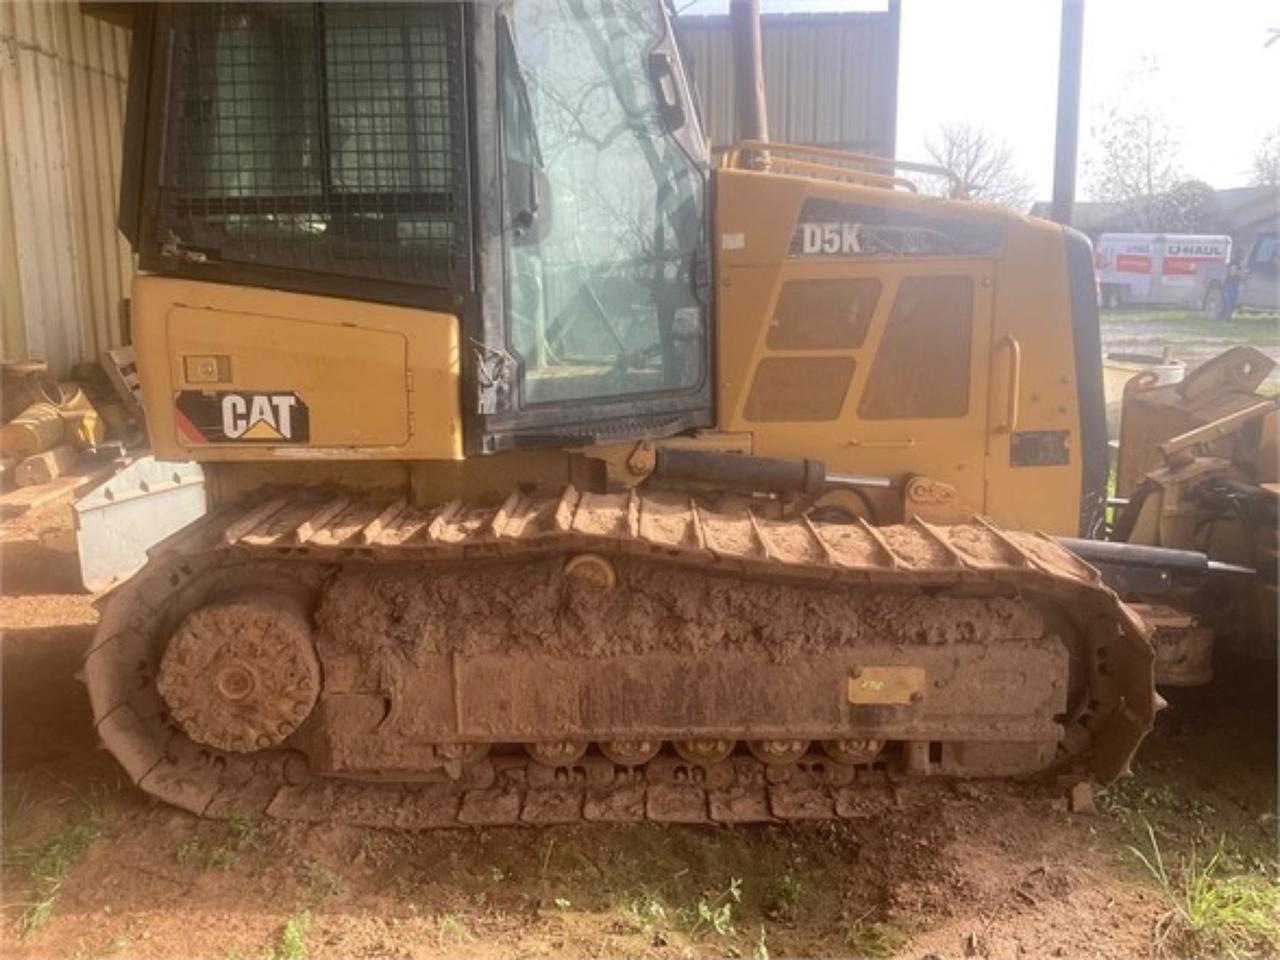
133 276 462 462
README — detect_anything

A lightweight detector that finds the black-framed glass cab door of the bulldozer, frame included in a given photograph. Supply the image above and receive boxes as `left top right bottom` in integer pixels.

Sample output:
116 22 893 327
467 0 712 452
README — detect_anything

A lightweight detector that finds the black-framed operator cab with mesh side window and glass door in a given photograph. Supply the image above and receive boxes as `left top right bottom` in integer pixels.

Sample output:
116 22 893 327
120 0 713 453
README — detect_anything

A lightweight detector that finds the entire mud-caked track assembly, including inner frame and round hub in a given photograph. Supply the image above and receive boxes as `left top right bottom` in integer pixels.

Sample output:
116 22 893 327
86 488 1156 827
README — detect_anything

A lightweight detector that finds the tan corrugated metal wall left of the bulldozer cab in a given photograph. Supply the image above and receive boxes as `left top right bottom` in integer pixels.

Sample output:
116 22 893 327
0 0 133 374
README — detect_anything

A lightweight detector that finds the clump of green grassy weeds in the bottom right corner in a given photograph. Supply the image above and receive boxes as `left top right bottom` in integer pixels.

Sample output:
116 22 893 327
1129 820 1280 957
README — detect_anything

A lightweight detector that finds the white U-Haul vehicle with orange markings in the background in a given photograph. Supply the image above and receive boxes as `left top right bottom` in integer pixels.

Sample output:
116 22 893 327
1093 233 1231 307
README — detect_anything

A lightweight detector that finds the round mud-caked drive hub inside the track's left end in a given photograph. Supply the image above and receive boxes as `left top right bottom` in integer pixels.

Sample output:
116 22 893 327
156 593 320 753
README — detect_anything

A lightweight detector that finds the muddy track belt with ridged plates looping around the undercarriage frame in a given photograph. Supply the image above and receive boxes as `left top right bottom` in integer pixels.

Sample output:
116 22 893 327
86 488 1156 827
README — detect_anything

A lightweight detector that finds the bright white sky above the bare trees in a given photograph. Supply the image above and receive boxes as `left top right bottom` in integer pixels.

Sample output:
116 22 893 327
677 0 1280 200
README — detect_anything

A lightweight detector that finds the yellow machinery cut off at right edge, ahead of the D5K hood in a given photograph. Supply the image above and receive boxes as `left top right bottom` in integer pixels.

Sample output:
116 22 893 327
1112 344 1280 686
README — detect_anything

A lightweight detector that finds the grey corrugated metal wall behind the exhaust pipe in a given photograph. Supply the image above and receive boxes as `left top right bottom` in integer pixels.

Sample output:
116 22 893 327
680 4 897 156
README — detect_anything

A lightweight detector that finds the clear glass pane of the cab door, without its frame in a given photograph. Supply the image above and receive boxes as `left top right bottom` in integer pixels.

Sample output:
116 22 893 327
499 0 705 404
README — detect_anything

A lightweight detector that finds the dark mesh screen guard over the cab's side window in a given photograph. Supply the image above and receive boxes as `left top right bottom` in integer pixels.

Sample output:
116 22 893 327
157 3 470 287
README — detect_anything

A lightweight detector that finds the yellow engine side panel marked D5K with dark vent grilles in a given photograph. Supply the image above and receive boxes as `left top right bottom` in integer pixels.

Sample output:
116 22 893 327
716 169 1091 535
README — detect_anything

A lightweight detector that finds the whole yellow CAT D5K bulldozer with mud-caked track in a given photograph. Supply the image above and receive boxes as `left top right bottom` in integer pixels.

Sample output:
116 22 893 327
86 0 1158 827
